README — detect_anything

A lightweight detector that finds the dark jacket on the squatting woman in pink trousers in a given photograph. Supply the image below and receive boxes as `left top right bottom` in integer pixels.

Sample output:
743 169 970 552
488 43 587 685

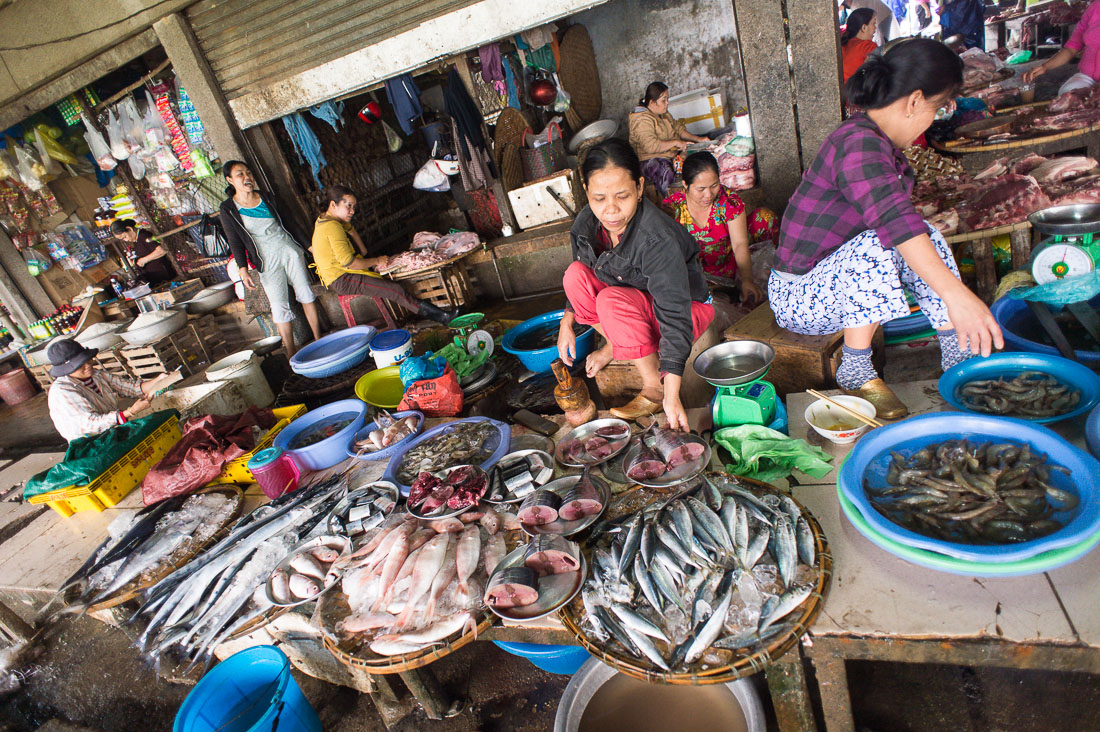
570 198 711 375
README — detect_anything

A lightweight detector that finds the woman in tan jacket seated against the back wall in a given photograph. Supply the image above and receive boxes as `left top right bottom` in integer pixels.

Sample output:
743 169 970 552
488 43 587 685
629 81 706 196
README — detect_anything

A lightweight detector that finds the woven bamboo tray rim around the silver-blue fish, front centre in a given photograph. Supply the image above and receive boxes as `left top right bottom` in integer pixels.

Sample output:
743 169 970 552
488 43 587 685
559 472 833 685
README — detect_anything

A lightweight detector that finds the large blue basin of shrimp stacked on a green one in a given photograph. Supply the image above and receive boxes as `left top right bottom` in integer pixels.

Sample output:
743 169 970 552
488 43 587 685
837 412 1100 577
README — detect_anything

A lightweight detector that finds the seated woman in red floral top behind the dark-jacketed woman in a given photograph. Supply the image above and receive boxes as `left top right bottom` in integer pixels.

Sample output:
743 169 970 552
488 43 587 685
664 153 765 306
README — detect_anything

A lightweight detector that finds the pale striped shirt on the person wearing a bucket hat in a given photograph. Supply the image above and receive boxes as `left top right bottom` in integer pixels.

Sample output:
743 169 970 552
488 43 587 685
47 369 143 441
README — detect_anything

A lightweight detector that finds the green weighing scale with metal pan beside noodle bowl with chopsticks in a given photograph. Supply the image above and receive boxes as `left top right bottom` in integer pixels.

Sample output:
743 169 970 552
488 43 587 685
692 340 787 431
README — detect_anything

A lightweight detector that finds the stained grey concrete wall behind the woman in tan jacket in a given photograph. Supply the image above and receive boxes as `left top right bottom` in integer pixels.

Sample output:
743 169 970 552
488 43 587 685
571 0 746 131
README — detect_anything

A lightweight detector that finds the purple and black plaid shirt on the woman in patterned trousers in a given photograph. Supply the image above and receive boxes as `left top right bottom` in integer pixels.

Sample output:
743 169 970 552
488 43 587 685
774 114 928 275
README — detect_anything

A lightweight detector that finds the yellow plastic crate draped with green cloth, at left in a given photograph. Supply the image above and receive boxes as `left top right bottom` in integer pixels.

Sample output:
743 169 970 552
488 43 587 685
28 419 183 518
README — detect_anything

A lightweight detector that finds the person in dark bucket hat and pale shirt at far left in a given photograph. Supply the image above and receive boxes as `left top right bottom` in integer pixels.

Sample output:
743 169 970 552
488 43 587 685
46 338 156 441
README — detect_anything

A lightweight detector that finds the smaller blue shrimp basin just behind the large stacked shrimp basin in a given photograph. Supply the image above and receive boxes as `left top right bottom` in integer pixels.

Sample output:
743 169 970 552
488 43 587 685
939 353 1100 424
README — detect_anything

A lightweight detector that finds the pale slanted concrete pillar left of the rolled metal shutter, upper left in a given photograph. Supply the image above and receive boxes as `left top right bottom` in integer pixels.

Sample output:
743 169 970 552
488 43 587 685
153 13 244 161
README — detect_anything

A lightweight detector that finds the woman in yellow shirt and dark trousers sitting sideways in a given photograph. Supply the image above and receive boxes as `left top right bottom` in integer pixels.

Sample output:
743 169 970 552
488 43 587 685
310 186 455 325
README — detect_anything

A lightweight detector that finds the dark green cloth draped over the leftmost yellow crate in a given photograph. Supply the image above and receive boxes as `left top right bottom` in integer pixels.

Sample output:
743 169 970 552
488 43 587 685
23 409 179 499
